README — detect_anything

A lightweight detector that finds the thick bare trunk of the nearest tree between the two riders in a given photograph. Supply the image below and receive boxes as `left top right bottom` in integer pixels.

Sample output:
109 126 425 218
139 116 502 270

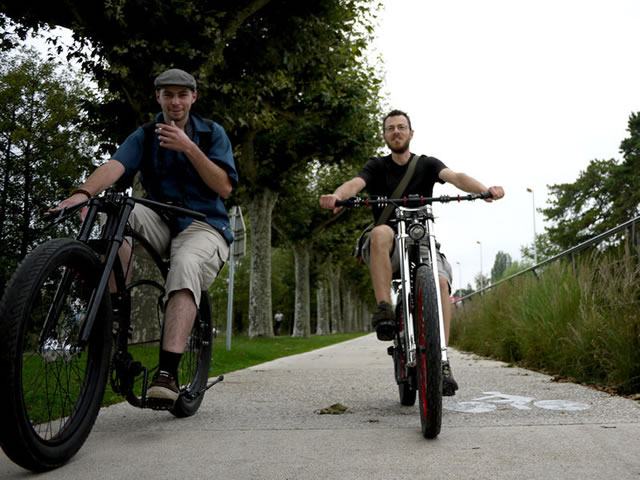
248 189 278 338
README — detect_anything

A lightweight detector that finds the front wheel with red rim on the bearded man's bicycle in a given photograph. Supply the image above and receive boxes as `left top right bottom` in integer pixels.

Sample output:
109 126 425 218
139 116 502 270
414 265 442 438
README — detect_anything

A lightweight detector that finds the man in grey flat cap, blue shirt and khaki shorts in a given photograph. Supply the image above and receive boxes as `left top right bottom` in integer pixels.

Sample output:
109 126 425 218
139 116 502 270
54 68 238 408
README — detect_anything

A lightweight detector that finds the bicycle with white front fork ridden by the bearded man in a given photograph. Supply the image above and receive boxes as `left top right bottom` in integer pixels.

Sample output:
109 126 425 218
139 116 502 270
335 192 491 439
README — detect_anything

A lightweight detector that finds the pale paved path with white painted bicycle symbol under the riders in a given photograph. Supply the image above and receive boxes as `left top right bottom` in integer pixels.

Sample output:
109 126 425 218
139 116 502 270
0 334 640 480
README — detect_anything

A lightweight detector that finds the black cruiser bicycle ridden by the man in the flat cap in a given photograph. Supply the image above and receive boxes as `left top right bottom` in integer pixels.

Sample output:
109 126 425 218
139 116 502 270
0 191 223 472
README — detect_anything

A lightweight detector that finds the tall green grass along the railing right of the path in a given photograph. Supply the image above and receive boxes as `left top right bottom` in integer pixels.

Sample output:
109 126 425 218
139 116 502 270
451 246 640 394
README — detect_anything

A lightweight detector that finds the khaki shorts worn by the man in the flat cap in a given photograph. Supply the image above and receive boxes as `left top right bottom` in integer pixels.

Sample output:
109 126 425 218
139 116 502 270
129 204 230 305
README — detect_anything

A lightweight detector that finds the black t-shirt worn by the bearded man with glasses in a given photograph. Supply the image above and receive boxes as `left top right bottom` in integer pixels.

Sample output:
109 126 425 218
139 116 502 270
357 155 447 225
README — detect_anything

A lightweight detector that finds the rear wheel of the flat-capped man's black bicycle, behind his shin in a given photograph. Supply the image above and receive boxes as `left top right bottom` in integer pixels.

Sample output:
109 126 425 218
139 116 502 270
171 290 213 418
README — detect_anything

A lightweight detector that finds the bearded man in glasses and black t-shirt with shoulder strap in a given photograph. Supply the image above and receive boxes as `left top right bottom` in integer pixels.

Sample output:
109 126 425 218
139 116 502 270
320 110 504 396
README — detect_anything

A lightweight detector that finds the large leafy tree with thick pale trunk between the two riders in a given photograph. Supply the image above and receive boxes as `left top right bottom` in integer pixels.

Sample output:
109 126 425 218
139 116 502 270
208 0 380 337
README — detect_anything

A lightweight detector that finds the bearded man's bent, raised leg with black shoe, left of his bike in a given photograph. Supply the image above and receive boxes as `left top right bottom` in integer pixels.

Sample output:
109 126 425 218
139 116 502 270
369 225 395 341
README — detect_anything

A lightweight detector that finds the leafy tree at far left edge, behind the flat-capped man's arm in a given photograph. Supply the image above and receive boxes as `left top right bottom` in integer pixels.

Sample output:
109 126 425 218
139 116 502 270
0 50 96 287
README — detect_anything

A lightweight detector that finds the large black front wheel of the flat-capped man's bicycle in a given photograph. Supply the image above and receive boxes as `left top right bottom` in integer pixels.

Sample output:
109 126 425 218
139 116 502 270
0 239 111 472
